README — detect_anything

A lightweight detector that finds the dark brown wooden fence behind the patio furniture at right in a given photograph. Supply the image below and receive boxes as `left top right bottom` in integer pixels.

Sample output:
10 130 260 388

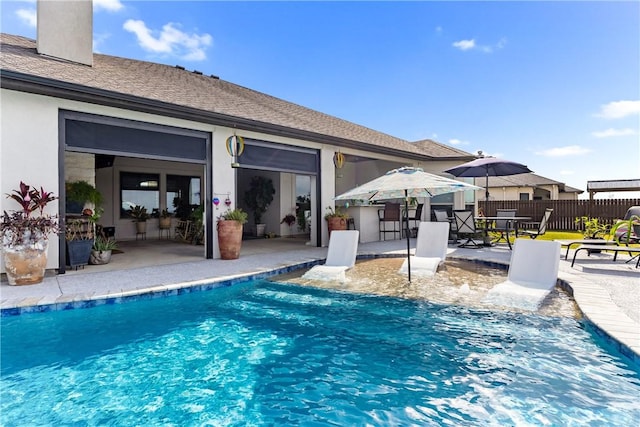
478 199 640 231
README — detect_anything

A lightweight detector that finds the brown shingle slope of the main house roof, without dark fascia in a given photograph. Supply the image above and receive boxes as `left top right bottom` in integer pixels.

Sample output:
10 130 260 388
0 34 476 162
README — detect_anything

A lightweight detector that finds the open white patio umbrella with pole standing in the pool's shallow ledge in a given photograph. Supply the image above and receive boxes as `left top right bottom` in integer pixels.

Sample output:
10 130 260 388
334 167 482 282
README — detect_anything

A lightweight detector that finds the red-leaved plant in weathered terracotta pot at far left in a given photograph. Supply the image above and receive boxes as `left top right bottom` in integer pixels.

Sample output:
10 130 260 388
0 181 59 285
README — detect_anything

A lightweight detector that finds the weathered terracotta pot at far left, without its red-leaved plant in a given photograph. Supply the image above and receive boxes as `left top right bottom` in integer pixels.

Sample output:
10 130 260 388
2 239 49 286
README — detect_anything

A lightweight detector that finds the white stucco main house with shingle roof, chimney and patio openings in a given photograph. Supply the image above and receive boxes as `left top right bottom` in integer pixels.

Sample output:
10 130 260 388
0 2 473 272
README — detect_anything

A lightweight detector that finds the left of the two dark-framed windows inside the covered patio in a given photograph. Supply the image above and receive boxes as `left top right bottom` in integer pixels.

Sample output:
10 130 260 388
120 172 160 218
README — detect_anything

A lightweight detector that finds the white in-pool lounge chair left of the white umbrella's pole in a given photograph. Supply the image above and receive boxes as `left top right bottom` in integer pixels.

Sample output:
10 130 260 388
302 230 360 282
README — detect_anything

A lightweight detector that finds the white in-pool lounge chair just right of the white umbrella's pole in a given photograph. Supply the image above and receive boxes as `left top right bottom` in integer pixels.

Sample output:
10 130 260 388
398 222 449 277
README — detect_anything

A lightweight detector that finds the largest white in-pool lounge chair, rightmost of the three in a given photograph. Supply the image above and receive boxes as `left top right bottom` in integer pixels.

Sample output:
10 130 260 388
484 239 560 311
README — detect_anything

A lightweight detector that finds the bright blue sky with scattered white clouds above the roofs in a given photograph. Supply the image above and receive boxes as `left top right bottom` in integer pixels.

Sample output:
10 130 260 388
1 0 640 197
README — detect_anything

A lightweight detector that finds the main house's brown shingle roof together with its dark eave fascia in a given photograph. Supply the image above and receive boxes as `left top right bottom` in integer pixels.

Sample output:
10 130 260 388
0 34 471 160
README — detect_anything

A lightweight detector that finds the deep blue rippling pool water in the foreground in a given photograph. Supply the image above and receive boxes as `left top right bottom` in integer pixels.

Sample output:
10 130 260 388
0 281 640 426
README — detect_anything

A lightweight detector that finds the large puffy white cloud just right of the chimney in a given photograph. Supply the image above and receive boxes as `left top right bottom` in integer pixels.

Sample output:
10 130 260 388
123 19 213 61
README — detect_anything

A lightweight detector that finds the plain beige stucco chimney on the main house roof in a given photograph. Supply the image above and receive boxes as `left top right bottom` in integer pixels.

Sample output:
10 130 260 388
37 0 93 66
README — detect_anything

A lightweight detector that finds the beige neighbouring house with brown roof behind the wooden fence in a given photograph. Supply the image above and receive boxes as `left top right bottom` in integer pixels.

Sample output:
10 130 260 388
475 173 584 200
